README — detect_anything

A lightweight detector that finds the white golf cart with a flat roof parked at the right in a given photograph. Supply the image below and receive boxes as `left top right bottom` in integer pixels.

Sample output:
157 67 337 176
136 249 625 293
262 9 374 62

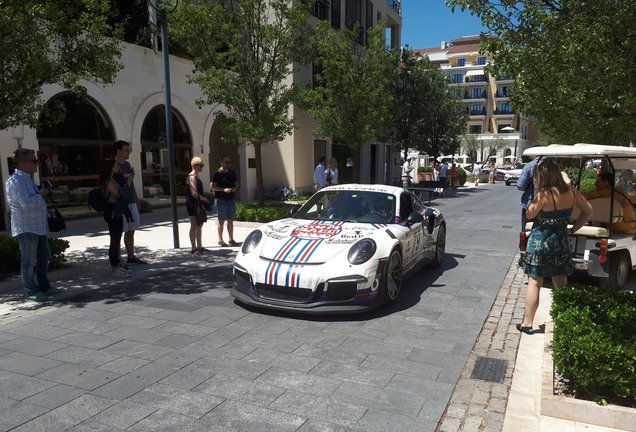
523 144 636 290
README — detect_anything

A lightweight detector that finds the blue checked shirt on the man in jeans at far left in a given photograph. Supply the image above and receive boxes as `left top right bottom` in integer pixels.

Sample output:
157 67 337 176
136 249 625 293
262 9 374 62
5 169 49 237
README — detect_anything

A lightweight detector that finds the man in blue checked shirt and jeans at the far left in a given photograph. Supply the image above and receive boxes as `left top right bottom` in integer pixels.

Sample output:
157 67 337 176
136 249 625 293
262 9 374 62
5 148 61 302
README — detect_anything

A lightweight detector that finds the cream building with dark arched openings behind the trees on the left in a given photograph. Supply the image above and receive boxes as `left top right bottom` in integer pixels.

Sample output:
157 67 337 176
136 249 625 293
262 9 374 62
0 0 402 230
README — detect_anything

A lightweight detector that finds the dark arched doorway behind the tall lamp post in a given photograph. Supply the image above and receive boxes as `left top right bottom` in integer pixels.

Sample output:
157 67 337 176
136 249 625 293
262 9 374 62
141 105 193 197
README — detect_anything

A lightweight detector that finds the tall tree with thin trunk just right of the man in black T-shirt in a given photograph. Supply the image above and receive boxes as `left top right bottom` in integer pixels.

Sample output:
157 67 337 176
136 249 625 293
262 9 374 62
171 0 310 205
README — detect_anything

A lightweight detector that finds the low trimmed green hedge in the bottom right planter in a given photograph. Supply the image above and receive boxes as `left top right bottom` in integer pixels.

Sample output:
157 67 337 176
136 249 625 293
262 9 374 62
550 286 636 404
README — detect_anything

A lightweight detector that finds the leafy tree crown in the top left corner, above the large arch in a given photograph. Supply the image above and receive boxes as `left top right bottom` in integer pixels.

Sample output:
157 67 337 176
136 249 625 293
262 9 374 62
0 0 121 130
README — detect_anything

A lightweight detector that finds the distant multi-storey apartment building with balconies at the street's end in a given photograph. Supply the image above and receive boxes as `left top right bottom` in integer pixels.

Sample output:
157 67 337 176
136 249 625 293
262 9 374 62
414 36 539 165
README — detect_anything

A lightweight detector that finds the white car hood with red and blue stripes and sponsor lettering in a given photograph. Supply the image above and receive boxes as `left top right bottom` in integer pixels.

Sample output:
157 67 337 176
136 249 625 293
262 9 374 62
260 218 389 264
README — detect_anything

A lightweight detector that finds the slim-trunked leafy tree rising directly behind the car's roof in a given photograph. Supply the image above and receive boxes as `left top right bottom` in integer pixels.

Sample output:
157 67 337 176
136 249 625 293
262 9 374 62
303 21 397 181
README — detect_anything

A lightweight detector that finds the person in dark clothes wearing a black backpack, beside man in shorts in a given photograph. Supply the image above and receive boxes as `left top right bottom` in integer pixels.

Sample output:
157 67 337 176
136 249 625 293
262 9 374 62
99 159 132 278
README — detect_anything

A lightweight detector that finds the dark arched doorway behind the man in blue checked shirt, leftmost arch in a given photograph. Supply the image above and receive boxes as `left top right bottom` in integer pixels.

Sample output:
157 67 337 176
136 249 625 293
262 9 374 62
37 93 115 206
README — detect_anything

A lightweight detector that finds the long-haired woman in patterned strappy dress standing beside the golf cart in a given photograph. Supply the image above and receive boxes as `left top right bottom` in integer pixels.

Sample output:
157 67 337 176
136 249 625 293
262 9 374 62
517 158 592 334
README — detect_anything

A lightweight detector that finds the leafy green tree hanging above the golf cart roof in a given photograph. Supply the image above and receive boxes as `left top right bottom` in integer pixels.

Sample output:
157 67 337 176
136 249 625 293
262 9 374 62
446 0 636 145
